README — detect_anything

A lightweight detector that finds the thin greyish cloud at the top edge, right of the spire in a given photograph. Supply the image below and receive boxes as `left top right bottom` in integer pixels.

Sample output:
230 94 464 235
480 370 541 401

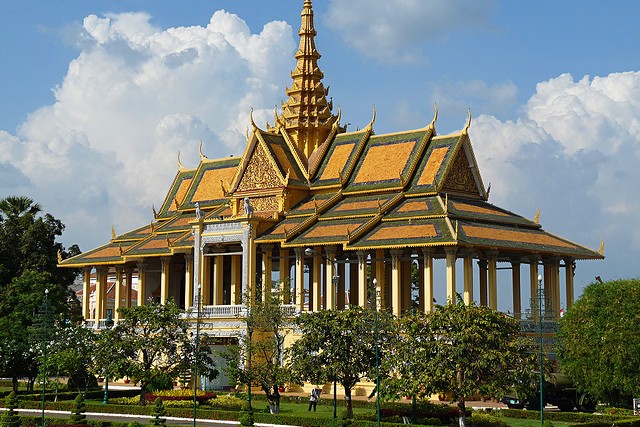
325 0 494 62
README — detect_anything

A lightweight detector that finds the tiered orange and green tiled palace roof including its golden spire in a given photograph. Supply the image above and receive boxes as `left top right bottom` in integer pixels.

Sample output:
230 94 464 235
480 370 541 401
61 0 602 267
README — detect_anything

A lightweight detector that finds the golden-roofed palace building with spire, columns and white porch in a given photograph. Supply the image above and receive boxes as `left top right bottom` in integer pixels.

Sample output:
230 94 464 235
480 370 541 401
60 0 603 388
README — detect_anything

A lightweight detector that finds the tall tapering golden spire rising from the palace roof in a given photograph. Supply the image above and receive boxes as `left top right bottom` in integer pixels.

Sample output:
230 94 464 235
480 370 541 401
269 0 344 158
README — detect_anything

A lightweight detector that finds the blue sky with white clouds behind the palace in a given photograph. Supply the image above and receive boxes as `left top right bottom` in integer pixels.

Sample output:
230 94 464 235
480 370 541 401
0 0 640 309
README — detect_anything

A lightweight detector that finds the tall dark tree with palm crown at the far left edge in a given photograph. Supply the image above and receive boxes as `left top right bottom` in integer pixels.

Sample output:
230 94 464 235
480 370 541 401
0 196 81 390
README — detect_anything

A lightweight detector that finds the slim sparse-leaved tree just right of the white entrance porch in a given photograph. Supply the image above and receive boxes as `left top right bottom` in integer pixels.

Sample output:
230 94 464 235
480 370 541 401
222 294 291 414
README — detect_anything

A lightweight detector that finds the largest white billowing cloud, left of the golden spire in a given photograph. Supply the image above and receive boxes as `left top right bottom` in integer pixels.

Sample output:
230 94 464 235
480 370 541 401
0 11 295 250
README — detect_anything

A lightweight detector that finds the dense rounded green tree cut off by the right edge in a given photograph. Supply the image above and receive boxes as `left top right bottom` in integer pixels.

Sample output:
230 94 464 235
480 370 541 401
558 279 640 406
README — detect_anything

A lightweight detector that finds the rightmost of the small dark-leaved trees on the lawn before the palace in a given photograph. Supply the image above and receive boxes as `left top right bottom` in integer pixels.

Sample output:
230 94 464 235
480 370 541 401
420 295 537 427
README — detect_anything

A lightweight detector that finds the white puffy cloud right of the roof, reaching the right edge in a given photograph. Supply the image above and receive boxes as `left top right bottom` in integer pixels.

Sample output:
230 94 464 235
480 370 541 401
470 72 640 283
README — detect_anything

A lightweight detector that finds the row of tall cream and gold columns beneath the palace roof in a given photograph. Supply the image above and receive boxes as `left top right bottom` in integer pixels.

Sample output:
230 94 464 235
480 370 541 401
82 245 575 320
